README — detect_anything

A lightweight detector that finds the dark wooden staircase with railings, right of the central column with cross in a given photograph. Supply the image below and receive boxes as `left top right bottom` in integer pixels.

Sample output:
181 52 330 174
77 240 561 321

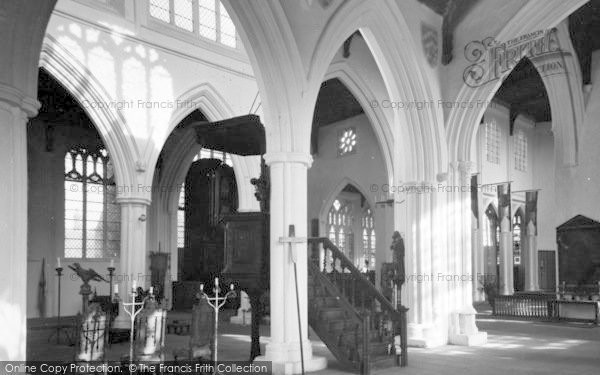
308 237 407 374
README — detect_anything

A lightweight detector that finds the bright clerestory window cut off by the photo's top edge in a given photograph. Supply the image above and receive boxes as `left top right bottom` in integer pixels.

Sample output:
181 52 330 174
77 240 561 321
149 0 237 48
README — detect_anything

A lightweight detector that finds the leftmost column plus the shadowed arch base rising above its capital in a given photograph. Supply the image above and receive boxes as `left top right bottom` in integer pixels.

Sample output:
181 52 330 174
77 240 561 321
0 0 56 361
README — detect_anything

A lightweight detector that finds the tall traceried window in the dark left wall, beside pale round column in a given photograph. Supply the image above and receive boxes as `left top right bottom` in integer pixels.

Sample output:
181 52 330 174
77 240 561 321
64 147 121 258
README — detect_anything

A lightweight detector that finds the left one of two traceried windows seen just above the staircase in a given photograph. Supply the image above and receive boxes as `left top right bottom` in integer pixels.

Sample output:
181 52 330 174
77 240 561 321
327 199 354 260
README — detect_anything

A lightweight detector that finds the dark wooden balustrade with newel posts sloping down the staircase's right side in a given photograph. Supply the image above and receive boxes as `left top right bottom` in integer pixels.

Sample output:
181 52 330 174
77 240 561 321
308 237 408 366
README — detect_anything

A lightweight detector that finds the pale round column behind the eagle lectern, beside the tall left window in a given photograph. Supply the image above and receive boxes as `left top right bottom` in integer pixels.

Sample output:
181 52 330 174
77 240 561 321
114 197 150 328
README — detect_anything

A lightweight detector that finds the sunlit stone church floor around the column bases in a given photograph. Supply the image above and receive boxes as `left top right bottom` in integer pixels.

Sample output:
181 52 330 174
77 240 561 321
28 313 600 375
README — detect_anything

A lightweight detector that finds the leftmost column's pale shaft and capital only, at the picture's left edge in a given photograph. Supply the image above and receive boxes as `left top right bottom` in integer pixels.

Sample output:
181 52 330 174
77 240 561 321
0 93 39 361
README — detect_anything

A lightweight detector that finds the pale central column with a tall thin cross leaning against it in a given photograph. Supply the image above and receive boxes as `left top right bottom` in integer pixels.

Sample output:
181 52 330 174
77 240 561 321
256 152 327 374
